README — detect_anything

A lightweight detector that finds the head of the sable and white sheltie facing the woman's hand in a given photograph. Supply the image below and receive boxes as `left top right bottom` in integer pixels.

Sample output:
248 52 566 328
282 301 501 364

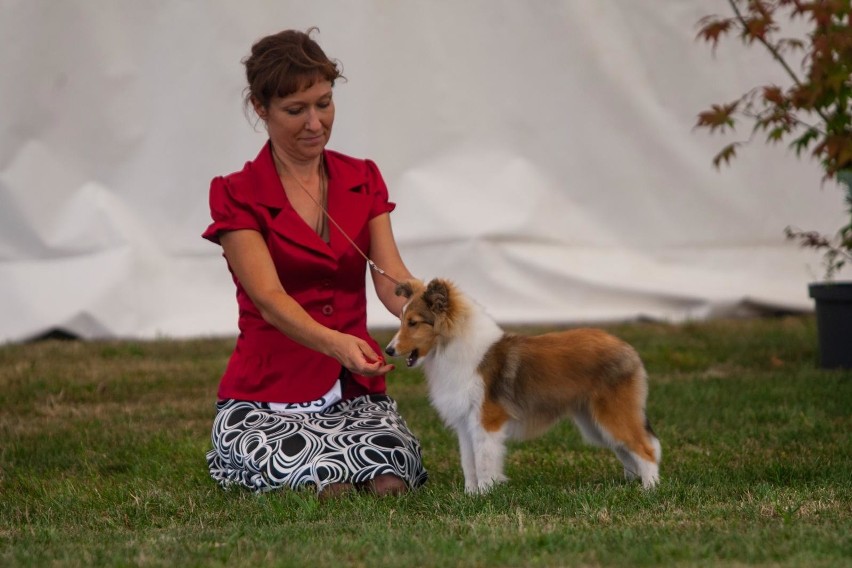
385 278 465 367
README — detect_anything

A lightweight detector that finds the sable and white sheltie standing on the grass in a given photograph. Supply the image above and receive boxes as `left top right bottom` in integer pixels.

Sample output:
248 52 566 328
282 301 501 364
386 279 662 493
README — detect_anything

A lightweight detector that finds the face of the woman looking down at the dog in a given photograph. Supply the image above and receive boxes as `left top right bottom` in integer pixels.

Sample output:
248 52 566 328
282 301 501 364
255 80 334 162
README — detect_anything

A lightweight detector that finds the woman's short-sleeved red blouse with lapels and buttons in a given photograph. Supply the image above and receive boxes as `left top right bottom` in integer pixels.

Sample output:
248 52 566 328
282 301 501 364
202 142 395 402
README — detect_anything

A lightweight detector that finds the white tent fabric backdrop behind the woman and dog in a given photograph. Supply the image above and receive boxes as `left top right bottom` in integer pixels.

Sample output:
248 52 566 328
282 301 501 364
0 0 842 341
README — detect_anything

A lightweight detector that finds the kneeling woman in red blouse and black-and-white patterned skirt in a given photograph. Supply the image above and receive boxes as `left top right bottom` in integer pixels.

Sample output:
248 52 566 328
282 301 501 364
203 28 427 496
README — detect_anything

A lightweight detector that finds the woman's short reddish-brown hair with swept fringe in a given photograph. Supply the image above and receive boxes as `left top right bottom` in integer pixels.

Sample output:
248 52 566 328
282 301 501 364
242 27 346 113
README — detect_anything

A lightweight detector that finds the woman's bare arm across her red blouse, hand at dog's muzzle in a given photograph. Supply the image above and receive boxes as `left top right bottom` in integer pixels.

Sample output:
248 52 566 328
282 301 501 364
219 230 393 376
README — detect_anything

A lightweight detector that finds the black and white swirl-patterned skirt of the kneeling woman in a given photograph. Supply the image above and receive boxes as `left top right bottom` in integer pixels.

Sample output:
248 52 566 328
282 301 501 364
207 395 427 492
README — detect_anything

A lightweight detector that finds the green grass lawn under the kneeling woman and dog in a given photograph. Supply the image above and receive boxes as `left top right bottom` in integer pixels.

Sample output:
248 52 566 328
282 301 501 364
0 318 852 567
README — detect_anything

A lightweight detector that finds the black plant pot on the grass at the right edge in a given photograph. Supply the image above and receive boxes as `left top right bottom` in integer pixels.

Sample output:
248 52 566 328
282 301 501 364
808 282 852 369
